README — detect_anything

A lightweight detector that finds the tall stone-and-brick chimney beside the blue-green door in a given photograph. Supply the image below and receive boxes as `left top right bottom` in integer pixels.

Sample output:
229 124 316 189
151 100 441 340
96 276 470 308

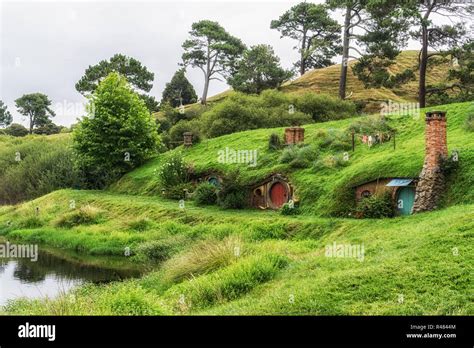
413 111 448 213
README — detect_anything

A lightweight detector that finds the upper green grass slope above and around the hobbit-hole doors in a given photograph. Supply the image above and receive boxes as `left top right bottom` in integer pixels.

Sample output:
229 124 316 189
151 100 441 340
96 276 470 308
111 103 474 216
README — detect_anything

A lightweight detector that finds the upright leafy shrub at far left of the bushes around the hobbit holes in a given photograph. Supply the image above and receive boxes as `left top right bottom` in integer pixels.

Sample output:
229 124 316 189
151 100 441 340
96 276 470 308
158 152 189 190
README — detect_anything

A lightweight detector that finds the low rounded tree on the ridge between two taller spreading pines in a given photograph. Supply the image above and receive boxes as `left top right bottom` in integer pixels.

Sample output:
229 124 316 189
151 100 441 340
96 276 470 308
228 45 293 94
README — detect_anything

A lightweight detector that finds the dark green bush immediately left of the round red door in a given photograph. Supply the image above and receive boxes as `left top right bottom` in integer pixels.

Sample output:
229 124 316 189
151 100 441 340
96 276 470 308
217 171 248 209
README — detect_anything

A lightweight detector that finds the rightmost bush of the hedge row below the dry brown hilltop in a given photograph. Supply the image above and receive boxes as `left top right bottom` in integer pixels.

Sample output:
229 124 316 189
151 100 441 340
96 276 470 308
294 92 357 122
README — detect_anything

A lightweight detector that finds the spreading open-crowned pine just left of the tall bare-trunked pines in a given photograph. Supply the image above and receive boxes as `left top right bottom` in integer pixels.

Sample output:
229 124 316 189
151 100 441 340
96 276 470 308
270 2 341 75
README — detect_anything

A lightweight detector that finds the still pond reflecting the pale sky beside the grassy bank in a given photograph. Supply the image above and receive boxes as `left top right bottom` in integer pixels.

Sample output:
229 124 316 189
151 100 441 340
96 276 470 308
0 241 141 306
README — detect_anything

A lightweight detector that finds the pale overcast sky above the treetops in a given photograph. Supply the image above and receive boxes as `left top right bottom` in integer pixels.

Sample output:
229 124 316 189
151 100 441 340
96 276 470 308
0 0 436 125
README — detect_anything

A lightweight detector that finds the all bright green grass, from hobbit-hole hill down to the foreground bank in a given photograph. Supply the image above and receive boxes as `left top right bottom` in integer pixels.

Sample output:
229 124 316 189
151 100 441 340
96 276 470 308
0 103 474 315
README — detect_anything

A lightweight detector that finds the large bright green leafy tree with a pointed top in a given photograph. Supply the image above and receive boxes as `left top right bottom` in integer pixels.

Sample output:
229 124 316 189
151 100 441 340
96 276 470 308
73 72 159 188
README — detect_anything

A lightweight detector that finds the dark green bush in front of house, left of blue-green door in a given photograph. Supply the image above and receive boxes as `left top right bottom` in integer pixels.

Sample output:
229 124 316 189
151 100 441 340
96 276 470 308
353 192 395 219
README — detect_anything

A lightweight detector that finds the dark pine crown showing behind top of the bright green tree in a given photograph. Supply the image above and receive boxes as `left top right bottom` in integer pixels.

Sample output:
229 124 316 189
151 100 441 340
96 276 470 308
76 54 159 112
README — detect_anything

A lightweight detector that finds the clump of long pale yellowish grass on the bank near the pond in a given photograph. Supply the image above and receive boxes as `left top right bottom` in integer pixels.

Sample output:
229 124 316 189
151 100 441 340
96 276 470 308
163 237 243 282
